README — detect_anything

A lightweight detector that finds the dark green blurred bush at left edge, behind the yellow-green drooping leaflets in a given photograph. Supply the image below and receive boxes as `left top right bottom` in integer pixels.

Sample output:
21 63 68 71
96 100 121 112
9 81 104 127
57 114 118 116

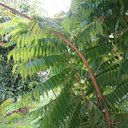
0 48 30 103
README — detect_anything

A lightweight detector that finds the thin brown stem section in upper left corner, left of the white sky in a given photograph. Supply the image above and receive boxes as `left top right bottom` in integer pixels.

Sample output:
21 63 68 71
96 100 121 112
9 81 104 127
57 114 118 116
0 3 32 20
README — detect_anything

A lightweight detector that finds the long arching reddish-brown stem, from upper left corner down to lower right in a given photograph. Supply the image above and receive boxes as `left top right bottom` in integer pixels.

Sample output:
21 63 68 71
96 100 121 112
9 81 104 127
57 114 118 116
0 3 111 128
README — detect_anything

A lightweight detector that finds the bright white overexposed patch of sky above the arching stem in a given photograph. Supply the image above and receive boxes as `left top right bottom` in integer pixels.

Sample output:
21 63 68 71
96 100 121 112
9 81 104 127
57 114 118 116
40 0 71 17
